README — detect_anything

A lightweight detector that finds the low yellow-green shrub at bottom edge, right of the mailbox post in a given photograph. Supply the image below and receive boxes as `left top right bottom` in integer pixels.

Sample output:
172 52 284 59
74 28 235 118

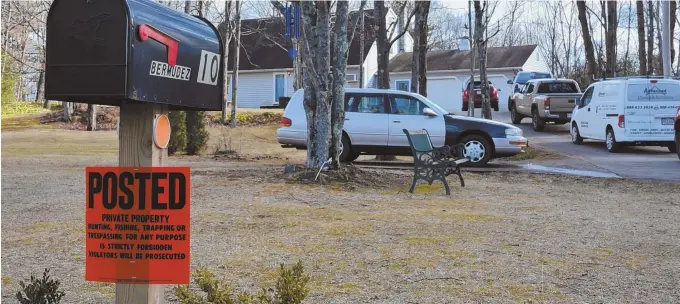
174 261 310 304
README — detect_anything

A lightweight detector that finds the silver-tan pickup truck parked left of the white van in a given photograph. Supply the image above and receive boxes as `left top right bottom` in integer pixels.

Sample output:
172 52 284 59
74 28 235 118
508 79 583 131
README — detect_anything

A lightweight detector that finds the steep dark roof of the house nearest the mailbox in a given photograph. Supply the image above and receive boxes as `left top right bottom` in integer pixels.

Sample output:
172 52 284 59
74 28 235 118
228 10 376 71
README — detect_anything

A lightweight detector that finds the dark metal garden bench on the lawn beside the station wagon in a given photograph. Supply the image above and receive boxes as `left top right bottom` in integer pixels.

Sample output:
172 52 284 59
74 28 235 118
403 129 470 195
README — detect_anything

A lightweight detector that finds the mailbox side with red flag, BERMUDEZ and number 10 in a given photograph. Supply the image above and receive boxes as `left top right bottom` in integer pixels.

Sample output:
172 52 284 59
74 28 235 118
127 0 224 111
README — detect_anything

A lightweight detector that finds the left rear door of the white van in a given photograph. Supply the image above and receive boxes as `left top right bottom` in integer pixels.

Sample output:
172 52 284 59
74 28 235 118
624 79 651 141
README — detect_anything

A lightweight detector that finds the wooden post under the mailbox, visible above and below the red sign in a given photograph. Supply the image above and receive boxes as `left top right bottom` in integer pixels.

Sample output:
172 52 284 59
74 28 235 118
116 102 168 304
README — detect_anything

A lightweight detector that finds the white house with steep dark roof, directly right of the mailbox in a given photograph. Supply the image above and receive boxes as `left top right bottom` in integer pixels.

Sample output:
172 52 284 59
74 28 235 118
227 10 413 108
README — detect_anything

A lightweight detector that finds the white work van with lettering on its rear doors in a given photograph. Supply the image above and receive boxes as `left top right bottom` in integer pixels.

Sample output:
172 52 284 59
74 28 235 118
571 77 680 152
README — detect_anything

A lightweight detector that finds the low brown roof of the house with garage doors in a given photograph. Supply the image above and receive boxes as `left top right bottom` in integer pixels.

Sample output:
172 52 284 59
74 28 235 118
389 45 536 72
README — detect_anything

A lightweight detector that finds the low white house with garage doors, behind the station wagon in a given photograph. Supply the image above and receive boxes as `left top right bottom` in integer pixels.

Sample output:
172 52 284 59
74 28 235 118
390 43 550 113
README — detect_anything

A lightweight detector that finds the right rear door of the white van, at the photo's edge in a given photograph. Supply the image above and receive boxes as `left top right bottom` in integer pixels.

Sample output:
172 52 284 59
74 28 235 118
647 79 680 141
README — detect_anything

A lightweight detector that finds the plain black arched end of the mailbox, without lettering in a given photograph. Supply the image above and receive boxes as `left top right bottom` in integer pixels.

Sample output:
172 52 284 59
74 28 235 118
45 0 128 105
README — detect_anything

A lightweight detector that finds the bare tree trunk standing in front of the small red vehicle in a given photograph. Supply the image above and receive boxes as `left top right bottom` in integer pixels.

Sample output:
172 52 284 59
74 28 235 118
471 1 492 119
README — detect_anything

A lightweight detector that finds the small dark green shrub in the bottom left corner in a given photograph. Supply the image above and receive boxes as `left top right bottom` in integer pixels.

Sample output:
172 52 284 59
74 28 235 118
16 268 65 304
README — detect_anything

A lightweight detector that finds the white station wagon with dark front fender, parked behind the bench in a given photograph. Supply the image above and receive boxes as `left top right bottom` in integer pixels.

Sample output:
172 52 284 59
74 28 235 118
276 88 528 166
